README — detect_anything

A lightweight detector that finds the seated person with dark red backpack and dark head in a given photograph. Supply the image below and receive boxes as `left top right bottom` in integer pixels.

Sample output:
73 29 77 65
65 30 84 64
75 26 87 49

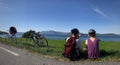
63 28 81 60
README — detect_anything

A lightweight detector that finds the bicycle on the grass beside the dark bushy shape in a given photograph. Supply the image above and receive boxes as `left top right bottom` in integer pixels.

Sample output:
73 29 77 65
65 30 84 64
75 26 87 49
26 32 48 47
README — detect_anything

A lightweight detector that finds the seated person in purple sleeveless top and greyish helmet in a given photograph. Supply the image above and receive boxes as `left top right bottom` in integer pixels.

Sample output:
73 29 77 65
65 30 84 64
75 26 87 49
85 29 100 59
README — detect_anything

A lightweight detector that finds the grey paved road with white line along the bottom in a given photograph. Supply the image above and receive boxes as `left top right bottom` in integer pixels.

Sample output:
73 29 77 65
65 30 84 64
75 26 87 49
0 43 120 65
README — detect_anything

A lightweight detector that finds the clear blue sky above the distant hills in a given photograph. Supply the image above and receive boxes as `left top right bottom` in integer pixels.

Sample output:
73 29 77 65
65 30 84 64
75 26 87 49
0 0 120 34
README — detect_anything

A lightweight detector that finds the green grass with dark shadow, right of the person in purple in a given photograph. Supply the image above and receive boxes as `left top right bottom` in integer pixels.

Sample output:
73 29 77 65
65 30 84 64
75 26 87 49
100 42 120 61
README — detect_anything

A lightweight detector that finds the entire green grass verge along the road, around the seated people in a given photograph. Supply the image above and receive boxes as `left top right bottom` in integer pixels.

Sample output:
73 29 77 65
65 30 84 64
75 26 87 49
0 38 120 61
